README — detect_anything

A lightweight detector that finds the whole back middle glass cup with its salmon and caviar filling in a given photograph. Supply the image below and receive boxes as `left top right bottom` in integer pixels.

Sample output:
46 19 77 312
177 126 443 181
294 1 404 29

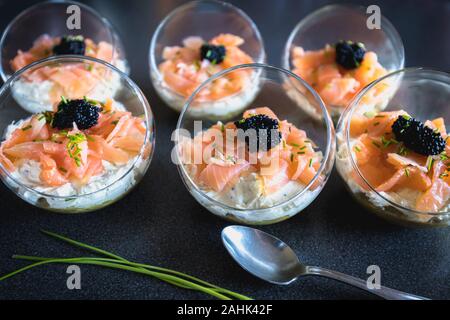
149 0 266 118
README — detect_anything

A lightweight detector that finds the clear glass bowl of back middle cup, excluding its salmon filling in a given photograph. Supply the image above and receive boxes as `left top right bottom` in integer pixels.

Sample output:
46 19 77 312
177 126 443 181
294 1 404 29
149 0 266 118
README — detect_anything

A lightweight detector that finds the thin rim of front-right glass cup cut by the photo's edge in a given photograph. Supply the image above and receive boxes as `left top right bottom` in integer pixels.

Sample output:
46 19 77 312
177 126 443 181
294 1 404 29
338 67 450 216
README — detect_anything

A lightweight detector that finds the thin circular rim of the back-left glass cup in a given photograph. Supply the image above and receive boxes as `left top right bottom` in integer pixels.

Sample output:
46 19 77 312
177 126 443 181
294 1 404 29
0 0 120 81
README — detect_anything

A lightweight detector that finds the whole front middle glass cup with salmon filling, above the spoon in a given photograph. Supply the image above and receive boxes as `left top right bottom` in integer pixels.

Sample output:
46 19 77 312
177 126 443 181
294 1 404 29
173 64 335 225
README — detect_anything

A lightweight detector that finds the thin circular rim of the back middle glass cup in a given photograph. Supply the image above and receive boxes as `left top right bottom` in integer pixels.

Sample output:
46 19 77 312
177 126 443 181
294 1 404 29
148 0 266 102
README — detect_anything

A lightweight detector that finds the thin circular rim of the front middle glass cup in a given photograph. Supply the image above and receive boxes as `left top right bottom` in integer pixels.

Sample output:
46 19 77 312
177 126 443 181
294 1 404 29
175 63 334 212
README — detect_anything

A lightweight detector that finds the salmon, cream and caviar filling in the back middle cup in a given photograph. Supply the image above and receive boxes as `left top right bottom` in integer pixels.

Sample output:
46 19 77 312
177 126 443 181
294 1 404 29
155 34 259 117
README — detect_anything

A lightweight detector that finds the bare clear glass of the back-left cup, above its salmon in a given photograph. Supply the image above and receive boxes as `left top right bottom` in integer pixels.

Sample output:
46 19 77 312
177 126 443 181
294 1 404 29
0 1 129 81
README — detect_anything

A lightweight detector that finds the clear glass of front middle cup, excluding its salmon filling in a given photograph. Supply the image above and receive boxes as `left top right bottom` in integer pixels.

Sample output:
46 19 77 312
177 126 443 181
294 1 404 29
174 64 335 225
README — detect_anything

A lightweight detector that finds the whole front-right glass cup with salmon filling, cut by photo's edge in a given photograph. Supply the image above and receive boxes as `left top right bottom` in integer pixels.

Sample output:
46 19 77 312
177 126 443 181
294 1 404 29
336 68 450 226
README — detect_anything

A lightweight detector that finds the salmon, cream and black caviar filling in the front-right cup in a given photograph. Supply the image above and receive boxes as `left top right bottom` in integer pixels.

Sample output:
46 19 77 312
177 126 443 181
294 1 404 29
337 110 450 225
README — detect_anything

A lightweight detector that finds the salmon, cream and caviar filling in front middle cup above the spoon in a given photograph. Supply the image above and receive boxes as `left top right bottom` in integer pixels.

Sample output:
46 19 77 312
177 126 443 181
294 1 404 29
181 107 322 220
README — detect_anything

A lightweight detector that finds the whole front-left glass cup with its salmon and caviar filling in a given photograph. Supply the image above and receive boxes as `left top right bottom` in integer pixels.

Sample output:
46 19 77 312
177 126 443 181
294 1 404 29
0 56 155 213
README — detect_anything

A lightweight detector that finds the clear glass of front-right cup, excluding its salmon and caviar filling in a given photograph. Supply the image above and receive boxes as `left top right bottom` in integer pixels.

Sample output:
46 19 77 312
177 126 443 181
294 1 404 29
336 68 450 226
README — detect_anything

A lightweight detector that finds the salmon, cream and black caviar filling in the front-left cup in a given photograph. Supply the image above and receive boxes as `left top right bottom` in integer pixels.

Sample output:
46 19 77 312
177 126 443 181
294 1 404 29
0 97 151 210
